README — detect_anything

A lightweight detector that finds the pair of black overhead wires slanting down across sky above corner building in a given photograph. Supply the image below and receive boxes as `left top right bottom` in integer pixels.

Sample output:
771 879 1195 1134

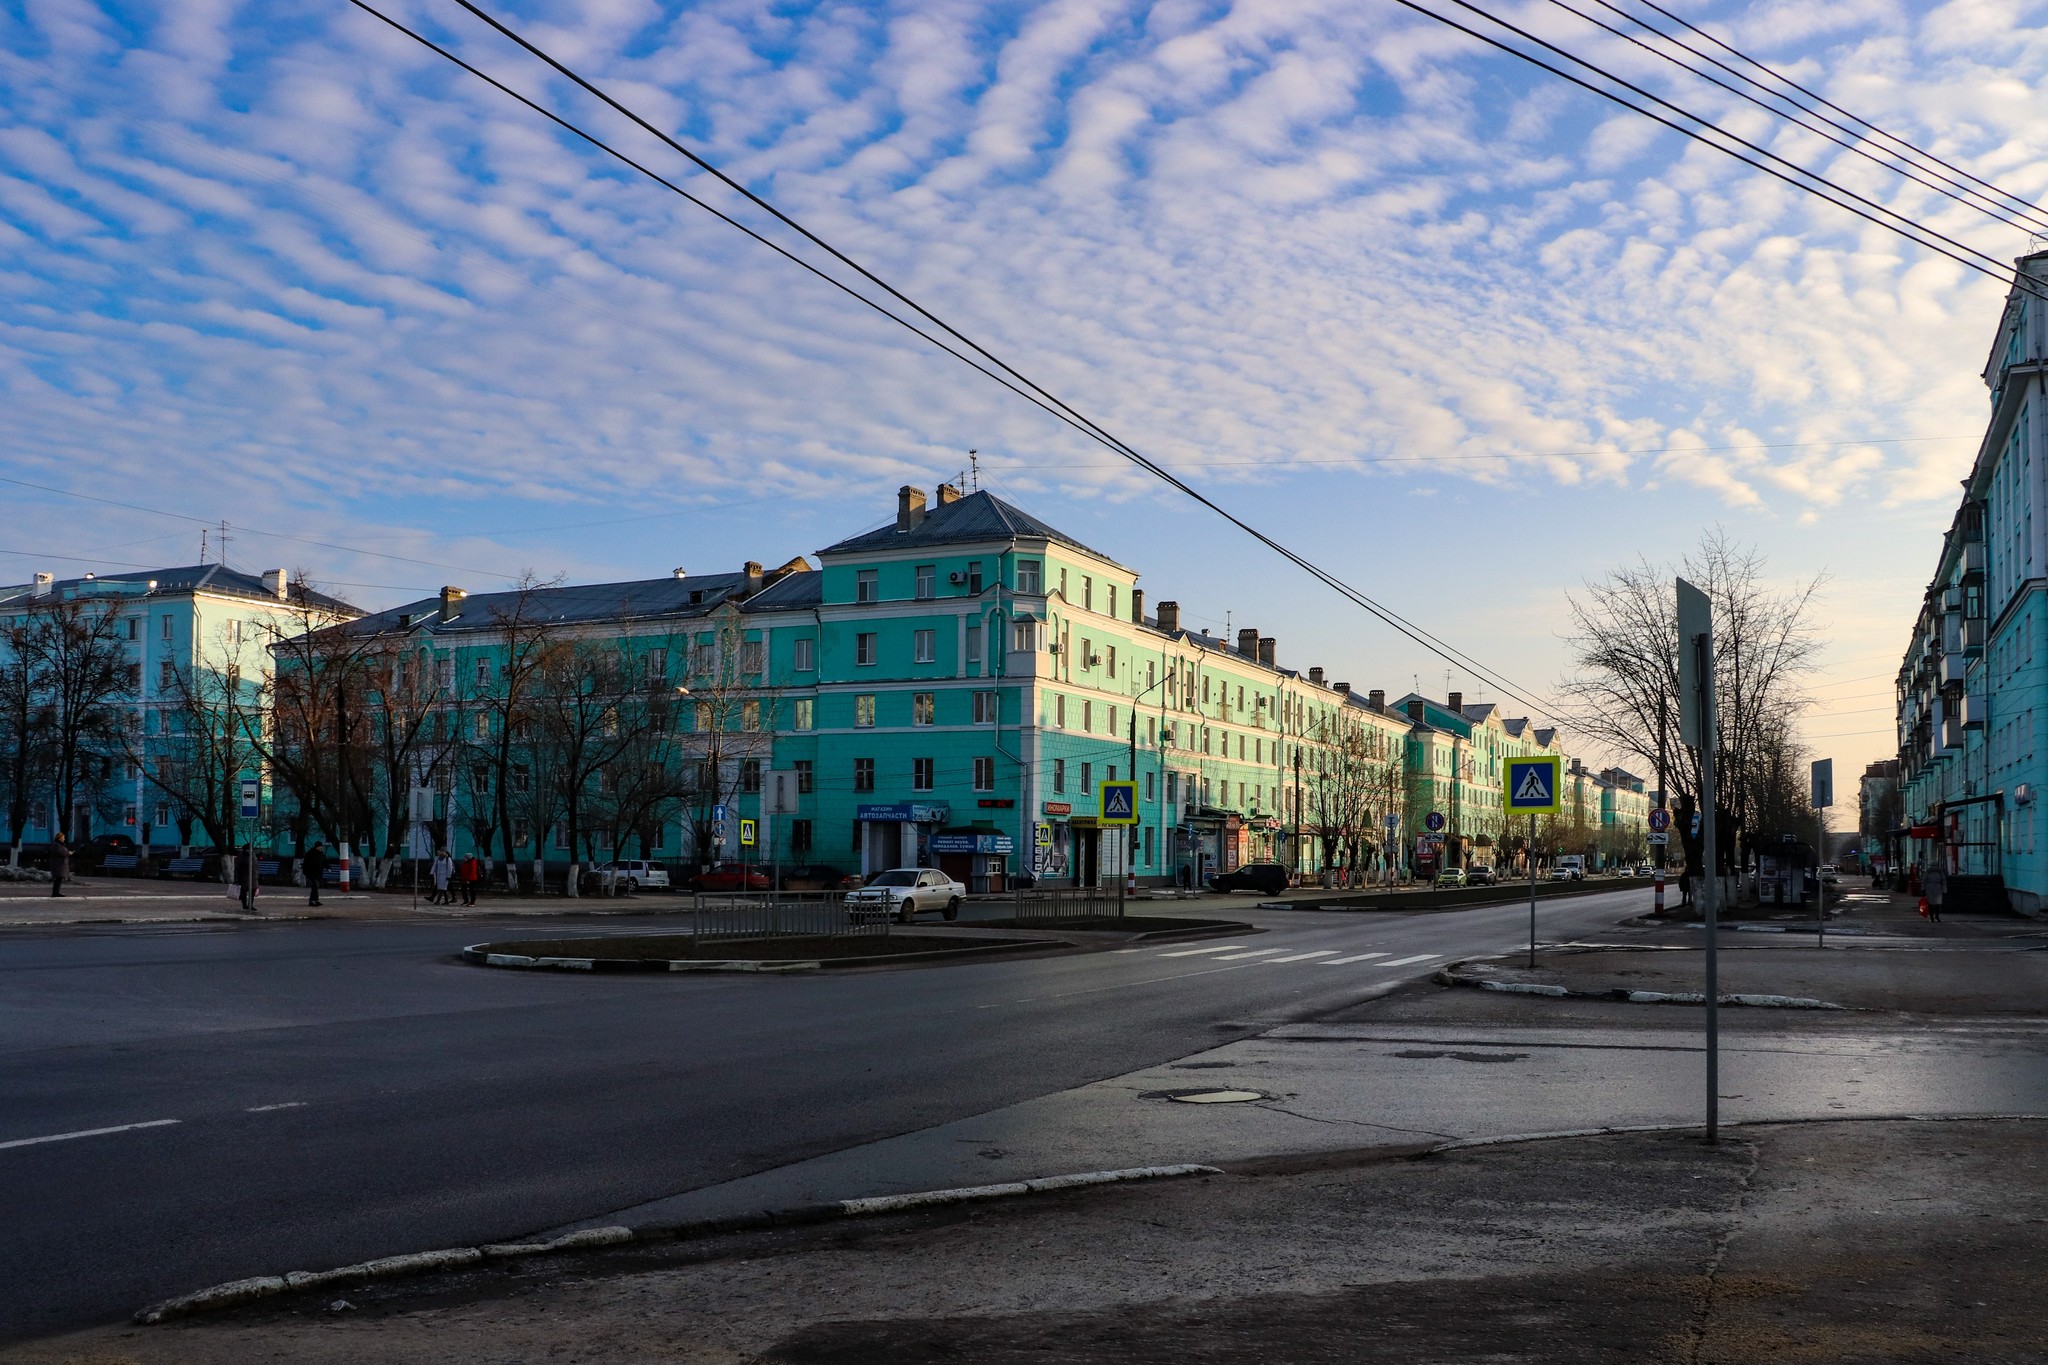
350 0 1550 724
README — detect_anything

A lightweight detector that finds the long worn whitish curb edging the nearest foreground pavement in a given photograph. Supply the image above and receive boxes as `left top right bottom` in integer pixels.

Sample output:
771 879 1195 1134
133 1162 1223 1326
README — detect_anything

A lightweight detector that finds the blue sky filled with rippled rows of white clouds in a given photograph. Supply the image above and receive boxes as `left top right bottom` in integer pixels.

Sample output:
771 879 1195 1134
0 0 2048 789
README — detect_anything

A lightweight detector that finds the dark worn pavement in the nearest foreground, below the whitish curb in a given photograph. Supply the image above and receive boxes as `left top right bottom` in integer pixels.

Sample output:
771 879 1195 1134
12 1121 2048 1365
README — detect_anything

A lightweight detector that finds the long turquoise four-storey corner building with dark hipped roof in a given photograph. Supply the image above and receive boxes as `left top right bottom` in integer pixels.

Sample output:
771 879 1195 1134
319 485 1589 890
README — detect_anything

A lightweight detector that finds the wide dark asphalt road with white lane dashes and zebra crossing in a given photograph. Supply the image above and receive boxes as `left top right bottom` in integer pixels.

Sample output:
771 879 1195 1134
0 892 1645 1340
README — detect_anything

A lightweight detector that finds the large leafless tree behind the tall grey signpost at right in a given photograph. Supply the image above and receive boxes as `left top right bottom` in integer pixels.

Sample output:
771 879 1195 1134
1561 528 1825 871
